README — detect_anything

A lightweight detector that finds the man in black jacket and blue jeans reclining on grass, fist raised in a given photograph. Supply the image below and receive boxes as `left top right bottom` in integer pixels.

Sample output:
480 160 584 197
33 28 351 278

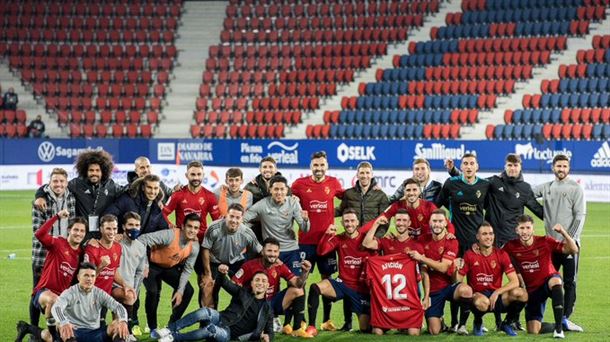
151 265 274 342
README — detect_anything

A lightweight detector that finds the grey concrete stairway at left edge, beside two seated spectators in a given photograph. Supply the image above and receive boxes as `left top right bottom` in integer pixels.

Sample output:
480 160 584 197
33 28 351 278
0 58 59 138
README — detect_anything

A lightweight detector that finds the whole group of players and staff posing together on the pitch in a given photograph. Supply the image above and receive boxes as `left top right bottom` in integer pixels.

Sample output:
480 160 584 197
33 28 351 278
17 151 585 342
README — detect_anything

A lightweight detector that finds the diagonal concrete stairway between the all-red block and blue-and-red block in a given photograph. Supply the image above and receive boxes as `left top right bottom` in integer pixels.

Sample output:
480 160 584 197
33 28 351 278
286 1 461 139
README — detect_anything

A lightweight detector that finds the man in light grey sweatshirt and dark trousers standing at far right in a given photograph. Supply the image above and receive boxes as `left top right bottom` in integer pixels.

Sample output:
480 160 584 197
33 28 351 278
534 154 587 332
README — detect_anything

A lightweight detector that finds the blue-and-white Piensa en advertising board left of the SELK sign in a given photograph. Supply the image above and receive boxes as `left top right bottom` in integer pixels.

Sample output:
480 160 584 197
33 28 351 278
239 141 299 165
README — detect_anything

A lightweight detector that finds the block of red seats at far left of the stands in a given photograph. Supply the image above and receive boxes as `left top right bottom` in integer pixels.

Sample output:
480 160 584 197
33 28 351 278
0 1 181 137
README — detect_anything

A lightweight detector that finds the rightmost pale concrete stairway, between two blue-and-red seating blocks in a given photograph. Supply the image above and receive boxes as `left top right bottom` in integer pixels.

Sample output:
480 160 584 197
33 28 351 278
461 8 610 140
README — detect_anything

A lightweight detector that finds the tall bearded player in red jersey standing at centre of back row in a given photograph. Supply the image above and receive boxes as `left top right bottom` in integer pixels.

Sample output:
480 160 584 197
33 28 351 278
291 151 344 331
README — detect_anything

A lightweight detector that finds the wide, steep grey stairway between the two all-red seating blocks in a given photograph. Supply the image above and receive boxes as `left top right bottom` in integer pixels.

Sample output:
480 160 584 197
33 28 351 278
155 1 227 138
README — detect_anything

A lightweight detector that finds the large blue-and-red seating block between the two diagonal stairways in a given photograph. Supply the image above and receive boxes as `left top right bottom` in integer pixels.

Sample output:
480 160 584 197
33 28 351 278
306 0 610 139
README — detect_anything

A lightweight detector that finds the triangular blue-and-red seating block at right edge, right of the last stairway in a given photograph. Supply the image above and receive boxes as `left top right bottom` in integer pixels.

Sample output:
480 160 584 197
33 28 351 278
487 31 610 140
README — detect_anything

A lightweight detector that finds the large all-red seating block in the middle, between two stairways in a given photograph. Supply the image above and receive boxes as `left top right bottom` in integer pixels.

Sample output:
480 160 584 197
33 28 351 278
191 0 438 138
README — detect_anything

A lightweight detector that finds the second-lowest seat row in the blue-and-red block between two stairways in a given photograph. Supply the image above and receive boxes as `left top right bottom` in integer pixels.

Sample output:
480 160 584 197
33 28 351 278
324 109 479 124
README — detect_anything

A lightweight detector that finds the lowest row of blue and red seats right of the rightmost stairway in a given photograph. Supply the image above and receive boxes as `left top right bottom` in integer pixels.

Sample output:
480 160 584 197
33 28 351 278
485 123 610 140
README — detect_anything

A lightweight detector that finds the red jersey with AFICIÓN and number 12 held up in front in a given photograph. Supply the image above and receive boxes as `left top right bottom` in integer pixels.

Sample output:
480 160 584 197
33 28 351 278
366 254 424 329
